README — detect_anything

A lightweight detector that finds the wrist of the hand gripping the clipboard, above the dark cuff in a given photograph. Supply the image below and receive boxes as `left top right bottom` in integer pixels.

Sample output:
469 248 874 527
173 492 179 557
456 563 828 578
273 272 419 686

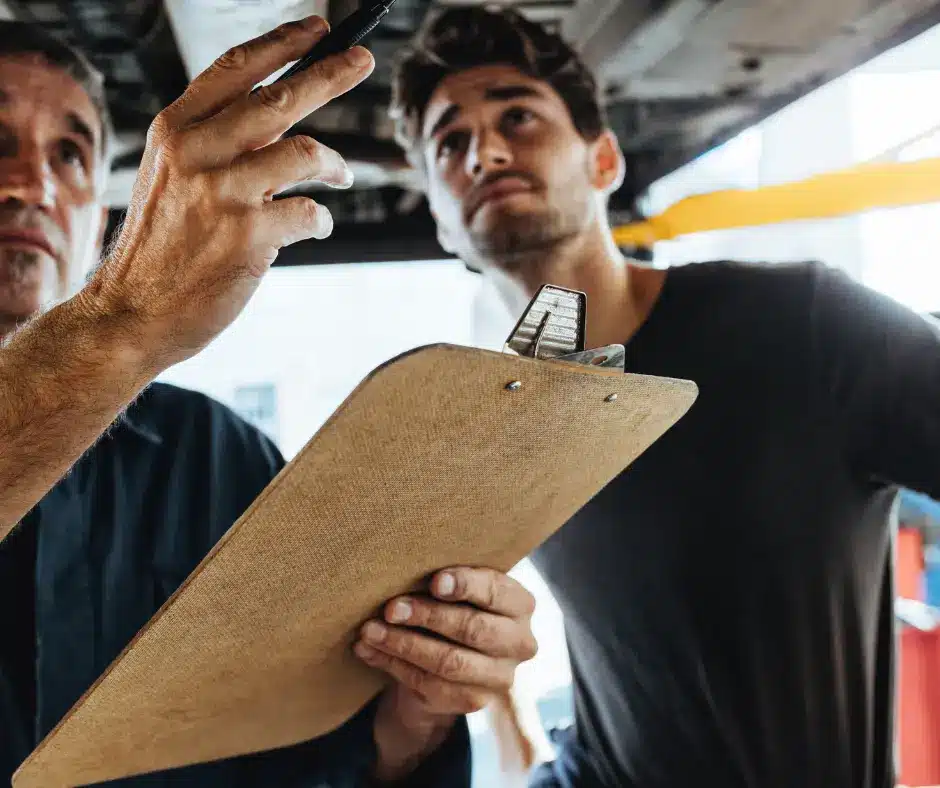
372 713 458 785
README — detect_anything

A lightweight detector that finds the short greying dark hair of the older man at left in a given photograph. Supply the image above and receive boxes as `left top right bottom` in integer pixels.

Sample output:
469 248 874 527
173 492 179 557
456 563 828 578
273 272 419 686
0 19 113 161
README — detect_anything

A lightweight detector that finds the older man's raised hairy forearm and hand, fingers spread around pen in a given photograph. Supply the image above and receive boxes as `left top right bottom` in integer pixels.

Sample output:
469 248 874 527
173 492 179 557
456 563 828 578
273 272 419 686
0 17 374 539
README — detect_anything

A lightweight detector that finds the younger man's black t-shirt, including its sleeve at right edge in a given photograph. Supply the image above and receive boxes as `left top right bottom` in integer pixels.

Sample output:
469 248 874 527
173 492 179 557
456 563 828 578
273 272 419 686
535 263 940 788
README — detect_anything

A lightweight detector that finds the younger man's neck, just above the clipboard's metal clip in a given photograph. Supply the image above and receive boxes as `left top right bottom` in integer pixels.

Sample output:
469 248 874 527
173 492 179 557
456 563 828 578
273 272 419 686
488 219 665 347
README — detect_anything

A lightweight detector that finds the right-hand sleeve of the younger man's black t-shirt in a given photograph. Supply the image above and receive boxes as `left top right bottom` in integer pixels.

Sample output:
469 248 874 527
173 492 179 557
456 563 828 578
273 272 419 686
810 266 940 498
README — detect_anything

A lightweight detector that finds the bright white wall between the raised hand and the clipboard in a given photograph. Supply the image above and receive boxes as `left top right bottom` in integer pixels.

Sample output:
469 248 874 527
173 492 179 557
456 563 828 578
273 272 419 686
163 261 478 458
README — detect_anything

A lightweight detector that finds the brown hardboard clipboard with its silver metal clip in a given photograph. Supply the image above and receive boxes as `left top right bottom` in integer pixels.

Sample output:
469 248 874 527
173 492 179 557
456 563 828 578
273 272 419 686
13 286 697 788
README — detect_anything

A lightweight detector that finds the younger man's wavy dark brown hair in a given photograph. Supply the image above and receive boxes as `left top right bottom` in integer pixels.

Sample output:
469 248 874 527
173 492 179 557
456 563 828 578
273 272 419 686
391 5 607 166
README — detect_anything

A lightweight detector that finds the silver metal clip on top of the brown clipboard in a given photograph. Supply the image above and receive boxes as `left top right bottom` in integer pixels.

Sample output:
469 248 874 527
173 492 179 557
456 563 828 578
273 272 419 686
503 285 626 370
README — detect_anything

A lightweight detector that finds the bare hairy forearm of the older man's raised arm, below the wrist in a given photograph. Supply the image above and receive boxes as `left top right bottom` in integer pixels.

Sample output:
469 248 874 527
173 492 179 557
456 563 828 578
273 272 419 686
0 298 157 540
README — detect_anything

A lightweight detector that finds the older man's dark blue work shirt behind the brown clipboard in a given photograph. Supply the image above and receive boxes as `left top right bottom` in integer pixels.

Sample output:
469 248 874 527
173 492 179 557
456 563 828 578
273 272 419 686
0 384 470 788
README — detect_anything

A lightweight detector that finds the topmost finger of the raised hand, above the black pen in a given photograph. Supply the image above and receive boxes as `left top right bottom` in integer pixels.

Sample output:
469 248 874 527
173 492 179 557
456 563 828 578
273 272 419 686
164 16 330 126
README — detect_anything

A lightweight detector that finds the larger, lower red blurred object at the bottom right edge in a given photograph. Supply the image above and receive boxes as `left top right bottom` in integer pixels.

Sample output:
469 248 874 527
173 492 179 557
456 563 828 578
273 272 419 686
898 627 940 785
